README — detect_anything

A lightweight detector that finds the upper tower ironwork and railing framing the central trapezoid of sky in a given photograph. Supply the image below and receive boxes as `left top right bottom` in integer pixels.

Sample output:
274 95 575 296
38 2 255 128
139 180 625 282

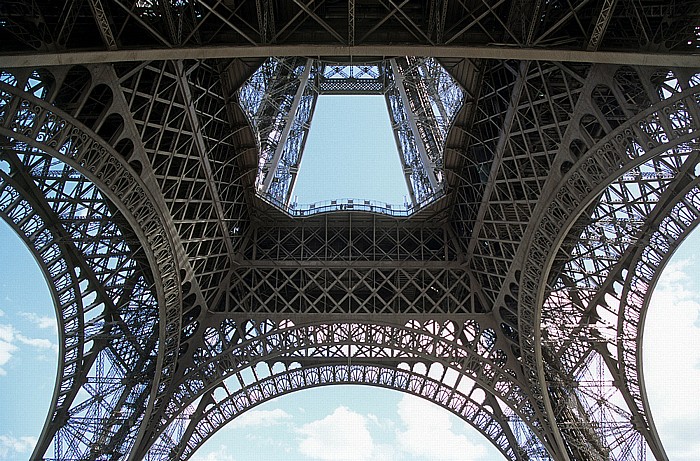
239 57 464 212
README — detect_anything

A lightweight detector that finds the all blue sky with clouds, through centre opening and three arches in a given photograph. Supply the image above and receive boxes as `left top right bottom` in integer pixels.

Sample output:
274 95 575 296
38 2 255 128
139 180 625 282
0 96 700 461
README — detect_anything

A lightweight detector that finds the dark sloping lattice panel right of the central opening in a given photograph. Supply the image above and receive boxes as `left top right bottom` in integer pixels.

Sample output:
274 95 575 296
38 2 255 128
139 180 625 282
471 63 587 300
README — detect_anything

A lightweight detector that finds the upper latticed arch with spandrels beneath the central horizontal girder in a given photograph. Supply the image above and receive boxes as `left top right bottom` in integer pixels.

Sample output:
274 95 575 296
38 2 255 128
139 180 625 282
148 319 542 458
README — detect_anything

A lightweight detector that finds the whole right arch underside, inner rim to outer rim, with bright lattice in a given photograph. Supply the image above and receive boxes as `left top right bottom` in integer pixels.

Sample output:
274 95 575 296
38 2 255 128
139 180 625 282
519 69 698 459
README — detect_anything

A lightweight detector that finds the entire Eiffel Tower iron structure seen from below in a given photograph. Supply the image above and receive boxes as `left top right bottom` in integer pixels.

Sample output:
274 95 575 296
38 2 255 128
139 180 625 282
0 0 700 461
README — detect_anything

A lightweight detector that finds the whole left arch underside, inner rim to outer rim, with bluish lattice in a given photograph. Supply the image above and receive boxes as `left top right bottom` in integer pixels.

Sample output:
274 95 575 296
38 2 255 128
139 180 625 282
0 66 180 459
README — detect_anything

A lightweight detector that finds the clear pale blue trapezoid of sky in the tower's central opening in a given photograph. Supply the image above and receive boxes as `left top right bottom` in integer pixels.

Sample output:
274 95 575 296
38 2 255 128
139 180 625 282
292 95 410 205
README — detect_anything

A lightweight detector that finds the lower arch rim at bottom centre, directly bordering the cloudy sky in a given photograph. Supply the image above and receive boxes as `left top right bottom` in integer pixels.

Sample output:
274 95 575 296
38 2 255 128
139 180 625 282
157 361 549 460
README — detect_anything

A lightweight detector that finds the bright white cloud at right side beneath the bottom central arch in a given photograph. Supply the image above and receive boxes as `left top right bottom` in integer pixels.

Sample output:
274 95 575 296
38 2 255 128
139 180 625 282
396 395 487 461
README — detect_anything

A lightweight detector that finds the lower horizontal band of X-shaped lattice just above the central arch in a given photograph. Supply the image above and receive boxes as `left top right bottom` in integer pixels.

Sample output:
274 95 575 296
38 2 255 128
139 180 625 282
226 267 475 314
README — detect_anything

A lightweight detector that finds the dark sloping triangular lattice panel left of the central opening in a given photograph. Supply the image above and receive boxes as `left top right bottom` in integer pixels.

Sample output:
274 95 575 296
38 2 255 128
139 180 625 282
117 62 234 301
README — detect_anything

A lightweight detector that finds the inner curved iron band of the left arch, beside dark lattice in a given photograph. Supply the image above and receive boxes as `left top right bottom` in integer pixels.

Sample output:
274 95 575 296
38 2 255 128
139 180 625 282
0 72 181 456
